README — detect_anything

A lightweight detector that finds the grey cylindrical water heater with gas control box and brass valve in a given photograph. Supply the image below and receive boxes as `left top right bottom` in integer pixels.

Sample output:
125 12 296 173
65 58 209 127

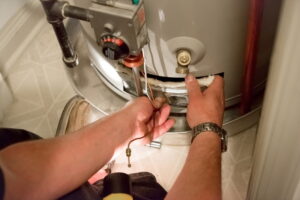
39 0 281 134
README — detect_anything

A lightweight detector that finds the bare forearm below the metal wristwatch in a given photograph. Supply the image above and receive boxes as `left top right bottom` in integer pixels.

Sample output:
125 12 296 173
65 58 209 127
166 132 221 200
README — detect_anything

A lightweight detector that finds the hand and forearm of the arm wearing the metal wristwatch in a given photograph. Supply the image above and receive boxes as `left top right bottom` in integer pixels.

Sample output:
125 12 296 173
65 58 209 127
166 75 224 200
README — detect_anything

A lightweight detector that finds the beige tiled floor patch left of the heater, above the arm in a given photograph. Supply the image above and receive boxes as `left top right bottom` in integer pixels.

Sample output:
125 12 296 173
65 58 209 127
1 23 75 138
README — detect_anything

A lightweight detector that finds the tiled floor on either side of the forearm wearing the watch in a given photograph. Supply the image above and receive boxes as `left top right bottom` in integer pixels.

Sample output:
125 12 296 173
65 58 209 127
113 124 256 200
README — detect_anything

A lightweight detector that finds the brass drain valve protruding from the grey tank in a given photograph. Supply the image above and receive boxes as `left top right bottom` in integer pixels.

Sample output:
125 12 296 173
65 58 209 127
176 49 192 74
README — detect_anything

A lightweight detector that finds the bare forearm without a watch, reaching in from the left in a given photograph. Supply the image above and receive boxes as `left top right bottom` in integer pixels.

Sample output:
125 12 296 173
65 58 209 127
0 111 131 199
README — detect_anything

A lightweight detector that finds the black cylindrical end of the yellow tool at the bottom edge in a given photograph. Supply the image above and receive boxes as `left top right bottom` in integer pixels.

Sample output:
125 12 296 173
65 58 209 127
103 172 132 197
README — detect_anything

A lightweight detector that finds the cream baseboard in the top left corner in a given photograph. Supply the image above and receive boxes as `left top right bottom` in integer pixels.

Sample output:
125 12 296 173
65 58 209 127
0 0 47 77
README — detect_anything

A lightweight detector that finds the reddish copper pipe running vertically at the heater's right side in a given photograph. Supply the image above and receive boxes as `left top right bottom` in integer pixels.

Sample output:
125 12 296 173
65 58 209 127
240 0 264 114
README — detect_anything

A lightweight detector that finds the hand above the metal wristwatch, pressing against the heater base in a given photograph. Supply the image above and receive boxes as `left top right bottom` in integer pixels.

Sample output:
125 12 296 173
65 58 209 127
185 75 224 128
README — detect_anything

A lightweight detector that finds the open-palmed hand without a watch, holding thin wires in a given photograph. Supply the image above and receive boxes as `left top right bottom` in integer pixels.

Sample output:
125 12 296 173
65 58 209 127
125 97 175 144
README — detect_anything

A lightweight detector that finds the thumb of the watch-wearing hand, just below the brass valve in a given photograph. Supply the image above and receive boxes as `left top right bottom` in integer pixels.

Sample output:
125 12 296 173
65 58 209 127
185 74 202 102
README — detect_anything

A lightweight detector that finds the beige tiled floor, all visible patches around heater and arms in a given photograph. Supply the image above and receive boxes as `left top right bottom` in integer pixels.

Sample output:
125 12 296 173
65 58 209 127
1 25 256 200
